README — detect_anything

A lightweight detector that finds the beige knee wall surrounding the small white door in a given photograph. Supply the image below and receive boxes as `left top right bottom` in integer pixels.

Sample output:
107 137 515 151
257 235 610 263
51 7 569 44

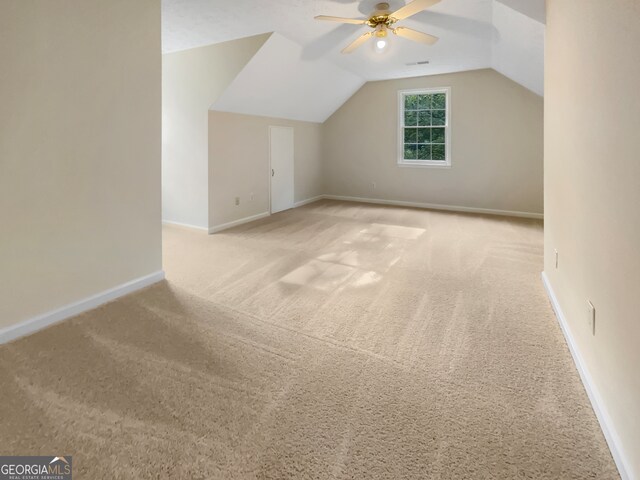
209 111 324 227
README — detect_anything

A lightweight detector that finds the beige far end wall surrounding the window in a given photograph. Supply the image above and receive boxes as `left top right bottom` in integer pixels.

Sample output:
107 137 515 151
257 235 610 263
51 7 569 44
324 70 543 213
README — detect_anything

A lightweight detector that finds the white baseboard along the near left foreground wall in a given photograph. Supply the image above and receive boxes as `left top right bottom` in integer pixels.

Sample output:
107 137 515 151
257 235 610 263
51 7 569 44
0 271 164 345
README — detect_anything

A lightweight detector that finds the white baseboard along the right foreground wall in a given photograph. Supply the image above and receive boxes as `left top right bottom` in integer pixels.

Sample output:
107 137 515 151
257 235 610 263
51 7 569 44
542 272 634 480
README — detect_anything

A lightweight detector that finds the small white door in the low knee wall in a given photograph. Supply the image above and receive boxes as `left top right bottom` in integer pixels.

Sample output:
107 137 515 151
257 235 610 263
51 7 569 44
269 127 293 213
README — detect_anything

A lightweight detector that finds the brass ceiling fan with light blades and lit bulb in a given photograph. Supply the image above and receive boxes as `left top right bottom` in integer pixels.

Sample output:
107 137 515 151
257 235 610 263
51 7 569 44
316 0 440 53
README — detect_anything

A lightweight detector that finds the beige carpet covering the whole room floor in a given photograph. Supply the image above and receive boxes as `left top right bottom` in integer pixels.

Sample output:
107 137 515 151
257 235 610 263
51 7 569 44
0 201 618 480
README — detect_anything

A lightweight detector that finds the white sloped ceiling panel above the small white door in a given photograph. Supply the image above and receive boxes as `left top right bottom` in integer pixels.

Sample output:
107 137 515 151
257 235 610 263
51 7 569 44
211 33 364 123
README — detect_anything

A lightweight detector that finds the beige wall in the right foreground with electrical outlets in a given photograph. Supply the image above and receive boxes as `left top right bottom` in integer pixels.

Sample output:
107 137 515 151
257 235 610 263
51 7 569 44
545 0 640 478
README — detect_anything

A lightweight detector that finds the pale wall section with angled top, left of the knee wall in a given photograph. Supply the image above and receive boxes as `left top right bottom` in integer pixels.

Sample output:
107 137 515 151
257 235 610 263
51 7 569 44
162 34 270 228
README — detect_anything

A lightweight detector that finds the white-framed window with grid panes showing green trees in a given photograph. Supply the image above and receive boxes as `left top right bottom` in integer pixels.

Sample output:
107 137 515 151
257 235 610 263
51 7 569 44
398 88 451 167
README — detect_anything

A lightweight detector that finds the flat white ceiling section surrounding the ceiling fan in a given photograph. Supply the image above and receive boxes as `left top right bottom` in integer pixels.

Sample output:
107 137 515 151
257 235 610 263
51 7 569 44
163 0 494 81
